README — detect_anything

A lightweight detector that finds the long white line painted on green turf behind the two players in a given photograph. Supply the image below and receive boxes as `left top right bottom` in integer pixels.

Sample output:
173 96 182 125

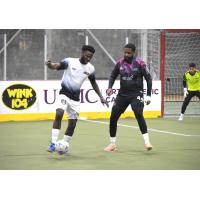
80 118 200 137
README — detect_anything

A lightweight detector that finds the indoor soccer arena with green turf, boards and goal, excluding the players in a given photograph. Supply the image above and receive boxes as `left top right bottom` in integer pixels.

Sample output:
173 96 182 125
0 29 200 170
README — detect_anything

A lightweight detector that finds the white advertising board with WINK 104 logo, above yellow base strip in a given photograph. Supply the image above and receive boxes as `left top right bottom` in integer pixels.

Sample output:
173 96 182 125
0 80 161 114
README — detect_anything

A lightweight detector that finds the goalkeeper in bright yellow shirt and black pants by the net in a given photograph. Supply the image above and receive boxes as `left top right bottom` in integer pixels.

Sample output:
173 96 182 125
179 63 200 121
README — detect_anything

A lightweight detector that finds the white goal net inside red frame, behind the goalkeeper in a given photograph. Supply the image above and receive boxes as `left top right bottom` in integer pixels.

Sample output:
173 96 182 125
164 31 200 115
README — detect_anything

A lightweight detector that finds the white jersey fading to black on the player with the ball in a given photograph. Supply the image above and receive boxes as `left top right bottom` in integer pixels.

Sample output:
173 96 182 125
60 58 95 101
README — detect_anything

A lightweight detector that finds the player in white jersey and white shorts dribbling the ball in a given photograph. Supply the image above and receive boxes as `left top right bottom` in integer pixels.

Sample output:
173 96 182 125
46 45 108 152
